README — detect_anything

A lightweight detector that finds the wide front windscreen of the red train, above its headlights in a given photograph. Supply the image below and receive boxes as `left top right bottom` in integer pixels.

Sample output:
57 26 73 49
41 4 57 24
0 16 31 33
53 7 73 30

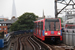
45 19 60 31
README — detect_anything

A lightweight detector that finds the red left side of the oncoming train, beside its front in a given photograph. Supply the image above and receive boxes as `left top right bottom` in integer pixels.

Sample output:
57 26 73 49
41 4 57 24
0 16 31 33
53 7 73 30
34 19 45 40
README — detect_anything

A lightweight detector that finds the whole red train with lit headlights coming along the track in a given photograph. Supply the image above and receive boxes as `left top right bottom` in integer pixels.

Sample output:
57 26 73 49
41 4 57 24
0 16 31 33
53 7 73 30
33 18 62 42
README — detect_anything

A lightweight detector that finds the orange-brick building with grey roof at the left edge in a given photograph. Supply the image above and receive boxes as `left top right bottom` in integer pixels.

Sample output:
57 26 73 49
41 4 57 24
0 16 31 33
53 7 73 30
0 18 18 34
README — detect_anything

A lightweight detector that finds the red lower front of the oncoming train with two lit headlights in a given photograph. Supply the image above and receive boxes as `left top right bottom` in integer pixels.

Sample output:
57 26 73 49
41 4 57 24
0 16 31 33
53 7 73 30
44 31 62 41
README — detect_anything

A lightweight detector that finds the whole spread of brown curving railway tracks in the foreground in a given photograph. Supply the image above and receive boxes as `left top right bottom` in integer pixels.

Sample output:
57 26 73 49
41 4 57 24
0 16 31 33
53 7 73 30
9 34 74 50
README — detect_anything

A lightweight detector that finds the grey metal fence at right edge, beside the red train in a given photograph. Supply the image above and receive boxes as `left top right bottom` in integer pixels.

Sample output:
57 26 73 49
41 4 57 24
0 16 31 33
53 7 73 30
62 31 75 46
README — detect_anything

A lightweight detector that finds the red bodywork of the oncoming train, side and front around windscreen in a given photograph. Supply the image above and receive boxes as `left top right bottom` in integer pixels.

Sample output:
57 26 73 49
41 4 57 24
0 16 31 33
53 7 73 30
34 19 62 41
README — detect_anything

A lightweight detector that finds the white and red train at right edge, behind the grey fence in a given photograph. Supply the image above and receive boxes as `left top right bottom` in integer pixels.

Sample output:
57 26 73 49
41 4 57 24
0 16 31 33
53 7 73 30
64 19 75 33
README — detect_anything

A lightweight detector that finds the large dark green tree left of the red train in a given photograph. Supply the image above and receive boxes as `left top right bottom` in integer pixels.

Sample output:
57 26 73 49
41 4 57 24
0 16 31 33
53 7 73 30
10 13 38 31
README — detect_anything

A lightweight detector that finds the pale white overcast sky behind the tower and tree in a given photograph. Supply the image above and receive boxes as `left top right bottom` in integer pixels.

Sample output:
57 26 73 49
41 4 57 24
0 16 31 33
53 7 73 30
0 0 73 18
